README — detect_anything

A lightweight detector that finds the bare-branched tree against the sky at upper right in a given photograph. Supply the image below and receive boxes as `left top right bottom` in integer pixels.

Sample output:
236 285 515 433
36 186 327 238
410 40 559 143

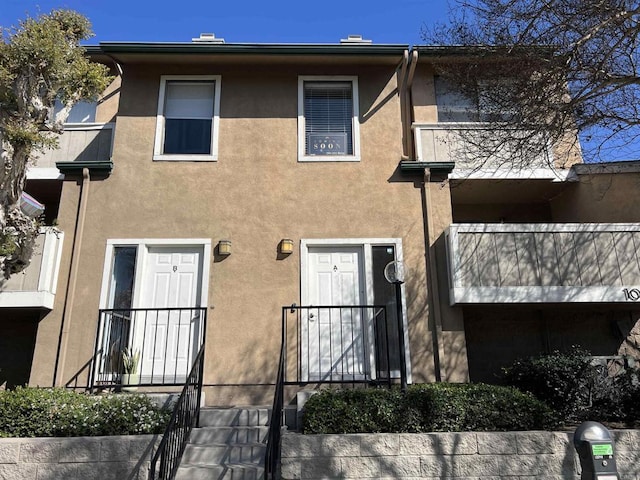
423 0 640 166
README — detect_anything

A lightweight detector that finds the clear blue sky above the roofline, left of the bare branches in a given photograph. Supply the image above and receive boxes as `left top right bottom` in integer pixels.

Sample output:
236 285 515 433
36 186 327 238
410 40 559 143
0 0 448 45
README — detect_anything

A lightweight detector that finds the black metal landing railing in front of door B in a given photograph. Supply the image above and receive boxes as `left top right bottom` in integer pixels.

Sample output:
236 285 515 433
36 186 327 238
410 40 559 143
89 307 207 390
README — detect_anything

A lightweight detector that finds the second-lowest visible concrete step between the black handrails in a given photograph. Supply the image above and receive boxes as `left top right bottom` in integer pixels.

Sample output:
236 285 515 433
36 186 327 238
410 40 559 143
181 443 267 466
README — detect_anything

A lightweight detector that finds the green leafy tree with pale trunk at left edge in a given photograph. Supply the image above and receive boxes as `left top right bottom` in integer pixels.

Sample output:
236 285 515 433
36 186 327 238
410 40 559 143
0 10 110 277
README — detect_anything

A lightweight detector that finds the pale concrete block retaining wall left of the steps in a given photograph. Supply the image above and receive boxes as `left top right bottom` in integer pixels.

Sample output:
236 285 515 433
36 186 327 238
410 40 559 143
0 435 161 480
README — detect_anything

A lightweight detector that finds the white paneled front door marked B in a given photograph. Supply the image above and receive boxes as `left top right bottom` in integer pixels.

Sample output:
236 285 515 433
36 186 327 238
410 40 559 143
134 246 203 383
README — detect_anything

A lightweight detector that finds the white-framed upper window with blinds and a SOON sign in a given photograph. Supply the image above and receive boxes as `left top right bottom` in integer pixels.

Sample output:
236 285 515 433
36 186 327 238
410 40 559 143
298 77 360 161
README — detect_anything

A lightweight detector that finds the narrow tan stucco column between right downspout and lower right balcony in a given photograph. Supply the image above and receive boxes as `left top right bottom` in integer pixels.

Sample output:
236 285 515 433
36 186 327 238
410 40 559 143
423 170 469 382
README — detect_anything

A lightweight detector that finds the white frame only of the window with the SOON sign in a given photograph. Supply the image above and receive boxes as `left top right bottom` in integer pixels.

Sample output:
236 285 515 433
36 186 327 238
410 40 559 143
298 75 360 162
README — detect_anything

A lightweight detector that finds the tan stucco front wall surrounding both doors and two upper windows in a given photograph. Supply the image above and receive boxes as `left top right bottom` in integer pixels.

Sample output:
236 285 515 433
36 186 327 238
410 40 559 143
31 60 450 403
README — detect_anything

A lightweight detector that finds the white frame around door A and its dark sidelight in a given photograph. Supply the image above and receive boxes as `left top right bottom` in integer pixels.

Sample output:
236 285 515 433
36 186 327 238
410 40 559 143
300 238 413 383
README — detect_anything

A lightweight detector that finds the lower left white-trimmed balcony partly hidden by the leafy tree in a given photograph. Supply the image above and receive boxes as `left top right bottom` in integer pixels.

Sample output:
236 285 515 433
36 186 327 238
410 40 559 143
0 227 64 310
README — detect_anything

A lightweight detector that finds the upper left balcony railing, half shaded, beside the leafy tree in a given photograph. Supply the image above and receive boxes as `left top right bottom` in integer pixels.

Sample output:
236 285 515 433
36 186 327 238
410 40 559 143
30 123 114 168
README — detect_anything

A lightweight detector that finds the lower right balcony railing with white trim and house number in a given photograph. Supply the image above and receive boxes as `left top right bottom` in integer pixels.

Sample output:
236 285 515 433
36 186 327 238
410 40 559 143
446 223 640 304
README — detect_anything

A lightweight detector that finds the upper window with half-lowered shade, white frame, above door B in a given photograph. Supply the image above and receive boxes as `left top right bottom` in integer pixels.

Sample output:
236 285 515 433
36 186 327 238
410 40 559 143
153 75 220 160
